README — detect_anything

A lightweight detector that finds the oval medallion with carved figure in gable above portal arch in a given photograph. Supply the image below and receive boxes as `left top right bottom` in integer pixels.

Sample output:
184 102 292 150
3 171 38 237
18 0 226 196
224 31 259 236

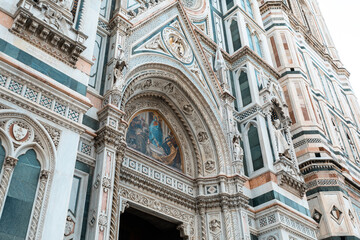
163 27 194 64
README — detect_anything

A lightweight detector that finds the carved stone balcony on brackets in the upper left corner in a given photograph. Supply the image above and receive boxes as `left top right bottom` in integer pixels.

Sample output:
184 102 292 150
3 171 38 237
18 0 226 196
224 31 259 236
10 0 87 66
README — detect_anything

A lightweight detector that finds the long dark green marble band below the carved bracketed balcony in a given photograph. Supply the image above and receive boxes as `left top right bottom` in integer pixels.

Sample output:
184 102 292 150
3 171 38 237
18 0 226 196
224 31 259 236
0 38 87 96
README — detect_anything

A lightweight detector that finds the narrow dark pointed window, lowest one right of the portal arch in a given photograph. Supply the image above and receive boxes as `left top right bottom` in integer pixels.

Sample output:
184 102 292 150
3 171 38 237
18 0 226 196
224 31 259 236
248 124 264 171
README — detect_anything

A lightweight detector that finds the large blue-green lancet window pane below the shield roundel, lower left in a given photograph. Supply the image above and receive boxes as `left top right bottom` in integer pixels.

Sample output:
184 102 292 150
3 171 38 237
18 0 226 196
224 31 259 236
0 150 40 240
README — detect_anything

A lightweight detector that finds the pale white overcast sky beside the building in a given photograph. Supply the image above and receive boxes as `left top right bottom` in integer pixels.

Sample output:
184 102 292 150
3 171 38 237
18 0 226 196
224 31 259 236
318 0 360 98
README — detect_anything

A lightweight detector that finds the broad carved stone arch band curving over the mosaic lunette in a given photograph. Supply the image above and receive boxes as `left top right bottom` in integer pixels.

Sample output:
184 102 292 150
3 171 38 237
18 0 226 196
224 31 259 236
120 64 230 175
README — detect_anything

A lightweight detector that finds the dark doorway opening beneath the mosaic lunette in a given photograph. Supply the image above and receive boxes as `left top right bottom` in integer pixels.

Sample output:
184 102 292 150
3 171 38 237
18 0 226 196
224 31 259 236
119 208 183 240
